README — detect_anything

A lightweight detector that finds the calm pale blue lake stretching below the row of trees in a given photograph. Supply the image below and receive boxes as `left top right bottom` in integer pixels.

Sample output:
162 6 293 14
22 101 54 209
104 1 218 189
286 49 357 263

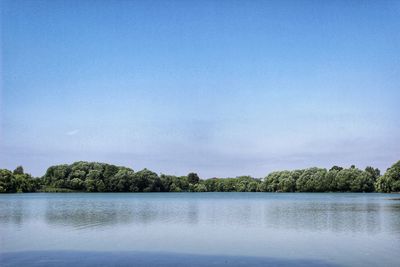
0 193 400 266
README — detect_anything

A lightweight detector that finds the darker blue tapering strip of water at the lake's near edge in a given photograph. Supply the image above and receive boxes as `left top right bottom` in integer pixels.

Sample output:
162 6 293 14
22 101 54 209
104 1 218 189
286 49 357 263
0 251 337 267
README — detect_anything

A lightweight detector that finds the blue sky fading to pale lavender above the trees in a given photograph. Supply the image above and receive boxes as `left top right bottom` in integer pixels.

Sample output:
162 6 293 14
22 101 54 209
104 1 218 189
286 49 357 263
0 0 400 178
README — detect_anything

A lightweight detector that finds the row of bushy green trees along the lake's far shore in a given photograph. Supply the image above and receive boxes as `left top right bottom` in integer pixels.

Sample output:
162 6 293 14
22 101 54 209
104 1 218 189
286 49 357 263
0 161 400 193
